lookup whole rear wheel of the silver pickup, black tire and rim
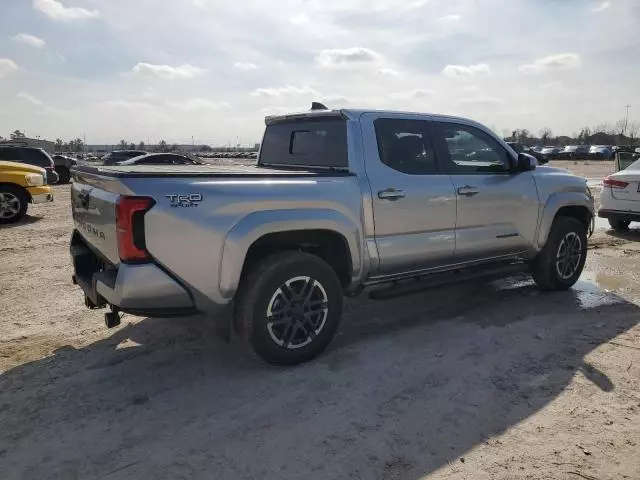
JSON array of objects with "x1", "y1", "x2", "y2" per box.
[{"x1": 236, "y1": 252, "x2": 343, "y2": 365}]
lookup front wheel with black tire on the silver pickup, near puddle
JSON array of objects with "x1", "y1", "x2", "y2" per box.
[{"x1": 531, "y1": 217, "x2": 587, "y2": 290}]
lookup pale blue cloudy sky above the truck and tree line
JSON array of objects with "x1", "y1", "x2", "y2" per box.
[{"x1": 0, "y1": 0, "x2": 640, "y2": 144}]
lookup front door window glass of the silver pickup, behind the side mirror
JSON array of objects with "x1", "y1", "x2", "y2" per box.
[{"x1": 434, "y1": 122, "x2": 509, "y2": 173}]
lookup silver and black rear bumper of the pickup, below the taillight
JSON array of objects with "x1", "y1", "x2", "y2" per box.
[{"x1": 70, "y1": 232, "x2": 198, "y2": 317}]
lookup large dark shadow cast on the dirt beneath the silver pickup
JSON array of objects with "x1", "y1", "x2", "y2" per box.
[{"x1": 0, "y1": 279, "x2": 640, "y2": 480}]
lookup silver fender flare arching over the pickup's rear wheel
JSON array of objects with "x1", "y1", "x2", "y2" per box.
[{"x1": 219, "y1": 208, "x2": 364, "y2": 299}]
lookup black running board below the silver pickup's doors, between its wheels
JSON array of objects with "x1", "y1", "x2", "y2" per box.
[{"x1": 369, "y1": 263, "x2": 530, "y2": 300}]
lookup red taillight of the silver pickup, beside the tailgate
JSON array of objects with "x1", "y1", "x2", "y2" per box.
[{"x1": 116, "y1": 196, "x2": 154, "y2": 262}]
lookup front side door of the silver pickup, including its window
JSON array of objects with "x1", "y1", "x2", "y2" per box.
[{"x1": 432, "y1": 121, "x2": 539, "y2": 262}]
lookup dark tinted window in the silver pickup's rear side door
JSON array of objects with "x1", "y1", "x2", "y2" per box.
[{"x1": 375, "y1": 118, "x2": 438, "y2": 175}]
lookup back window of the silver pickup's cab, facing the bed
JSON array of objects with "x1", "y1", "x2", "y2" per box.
[{"x1": 259, "y1": 118, "x2": 349, "y2": 168}]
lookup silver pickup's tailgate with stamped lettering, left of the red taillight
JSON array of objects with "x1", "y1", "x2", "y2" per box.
[{"x1": 71, "y1": 176, "x2": 120, "y2": 265}]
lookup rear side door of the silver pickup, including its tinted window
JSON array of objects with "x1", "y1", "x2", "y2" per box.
[{"x1": 361, "y1": 114, "x2": 456, "y2": 276}]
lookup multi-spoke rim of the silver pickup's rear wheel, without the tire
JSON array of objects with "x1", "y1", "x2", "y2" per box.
[{"x1": 266, "y1": 276, "x2": 329, "y2": 350}]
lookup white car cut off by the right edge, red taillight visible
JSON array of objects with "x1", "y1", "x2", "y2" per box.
[{"x1": 598, "y1": 156, "x2": 640, "y2": 232}]
